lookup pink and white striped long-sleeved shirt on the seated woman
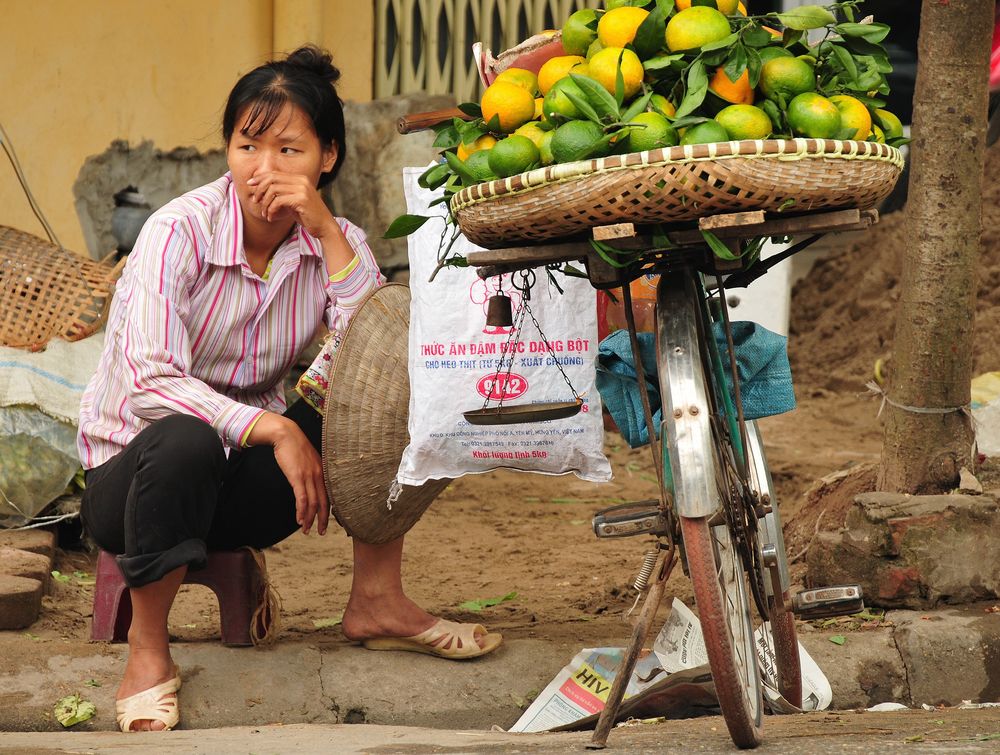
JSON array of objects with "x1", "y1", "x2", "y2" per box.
[{"x1": 77, "y1": 173, "x2": 385, "y2": 469}]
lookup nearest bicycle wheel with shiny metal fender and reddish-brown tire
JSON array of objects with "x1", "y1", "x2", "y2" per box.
[{"x1": 656, "y1": 272, "x2": 763, "y2": 748}]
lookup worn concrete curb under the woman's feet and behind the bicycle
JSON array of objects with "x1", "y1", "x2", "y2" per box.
[{"x1": 0, "y1": 604, "x2": 1000, "y2": 731}]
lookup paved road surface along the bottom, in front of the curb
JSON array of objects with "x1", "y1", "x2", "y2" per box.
[{"x1": 0, "y1": 708, "x2": 1000, "y2": 755}]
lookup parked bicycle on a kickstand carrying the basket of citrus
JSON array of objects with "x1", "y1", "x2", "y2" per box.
[{"x1": 399, "y1": 105, "x2": 878, "y2": 748}]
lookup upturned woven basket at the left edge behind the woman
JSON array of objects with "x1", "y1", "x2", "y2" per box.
[{"x1": 0, "y1": 226, "x2": 125, "y2": 351}]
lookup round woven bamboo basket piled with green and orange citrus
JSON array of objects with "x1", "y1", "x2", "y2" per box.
[{"x1": 451, "y1": 139, "x2": 903, "y2": 249}]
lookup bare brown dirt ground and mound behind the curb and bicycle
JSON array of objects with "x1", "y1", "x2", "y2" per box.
[{"x1": 31, "y1": 148, "x2": 1000, "y2": 660}]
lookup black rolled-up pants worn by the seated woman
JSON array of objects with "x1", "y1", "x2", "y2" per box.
[{"x1": 80, "y1": 401, "x2": 323, "y2": 587}]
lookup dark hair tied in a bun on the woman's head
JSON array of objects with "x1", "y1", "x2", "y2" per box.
[{"x1": 222, "y1": 45, "x2": 346, "y2": 188}]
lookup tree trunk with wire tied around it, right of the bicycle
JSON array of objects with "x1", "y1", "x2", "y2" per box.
[{"x1": 872, "y1": 0, "x2": 994, "y2": 493}]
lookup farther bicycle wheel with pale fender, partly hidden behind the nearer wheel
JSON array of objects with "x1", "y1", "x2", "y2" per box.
[{"x1": 747, "y1": 422, "x2": 802, "y2": 708}]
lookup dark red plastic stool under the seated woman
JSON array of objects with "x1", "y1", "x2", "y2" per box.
[{"x1": 90, "y1": 548, "x2": 264, "y2": 645}]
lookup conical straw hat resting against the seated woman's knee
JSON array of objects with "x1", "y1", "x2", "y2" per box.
[{"x1": 323, "y1": 283, "x2": 451, "y2": 544}]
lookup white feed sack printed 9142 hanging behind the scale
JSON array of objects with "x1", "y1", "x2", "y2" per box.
[{"x1": 398, "y1": 168, "x2": 611, "y2": 485}]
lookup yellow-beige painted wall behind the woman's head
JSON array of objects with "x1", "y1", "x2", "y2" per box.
[{"x1": 0, "y1": 0, "x2": 374, "y2": 254}]
